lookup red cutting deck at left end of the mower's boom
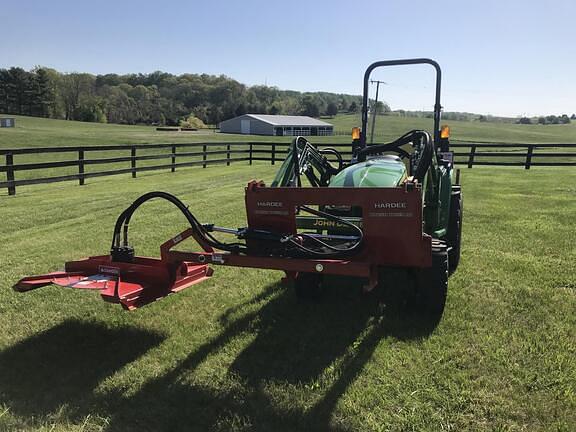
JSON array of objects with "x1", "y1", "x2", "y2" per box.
[{"x1": 14, "y1": 255, "x2": 212, "y2": 310}]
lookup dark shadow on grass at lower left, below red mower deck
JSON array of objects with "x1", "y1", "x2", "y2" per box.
[{"x1": 0, "y1": 320, "x2": 164, "y2": 419}]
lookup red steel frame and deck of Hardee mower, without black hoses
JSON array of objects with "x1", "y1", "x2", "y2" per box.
[{"x1": 14, "y1": 181, "x2": 432, "y2": 309}]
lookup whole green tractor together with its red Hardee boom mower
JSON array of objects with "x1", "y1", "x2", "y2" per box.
[{"x1": 14, "y1": 59, "x2": 462, "y2": 320}]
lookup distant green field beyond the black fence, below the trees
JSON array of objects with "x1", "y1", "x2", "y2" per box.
[{"x1": 0, "y1": 114, "x2": 576, "y2": 148}]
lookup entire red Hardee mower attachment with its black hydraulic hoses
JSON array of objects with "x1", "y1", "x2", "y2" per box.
[{"x1": 14, "y1": 182, "x2": 432, "y2": 310}]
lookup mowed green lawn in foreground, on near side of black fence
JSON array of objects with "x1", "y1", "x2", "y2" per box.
[{"x1": 0, "y1": 163, "x2": 576, "y2": 431}]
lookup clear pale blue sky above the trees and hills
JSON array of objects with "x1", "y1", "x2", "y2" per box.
[{"x1": 0, "y1": 0, "x2": 576, "y2": 116}]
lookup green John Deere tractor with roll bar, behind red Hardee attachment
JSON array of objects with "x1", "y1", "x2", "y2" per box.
[{"x1": 272, "y1": 59, "x2": 462, "y2": 318}]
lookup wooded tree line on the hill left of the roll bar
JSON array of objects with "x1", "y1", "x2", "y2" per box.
[{"x1": 0, "y1": 67, "x2": 362, "y2": 125}]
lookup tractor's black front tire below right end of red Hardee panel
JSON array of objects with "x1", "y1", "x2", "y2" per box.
[{"x1": 414, "y1": 243, "x2": 448, "y2": 327}]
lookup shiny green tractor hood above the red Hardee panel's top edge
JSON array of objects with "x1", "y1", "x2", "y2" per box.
[{"x1": 329, "y1": 155, "x2": 407, "y2": 187}]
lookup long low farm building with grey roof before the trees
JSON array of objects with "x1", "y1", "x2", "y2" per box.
[{"x1": 220, "y1": 114, "x2": 334, "y2": 136}]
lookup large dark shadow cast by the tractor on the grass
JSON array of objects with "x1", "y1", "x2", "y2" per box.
[{"x1": 103, "y1": 284, "x2": 436, "y2": 432}]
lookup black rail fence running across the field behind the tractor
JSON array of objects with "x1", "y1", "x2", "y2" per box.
[{"x1": 0, "y1": 142, "x2": 576, "y2": 195}]
